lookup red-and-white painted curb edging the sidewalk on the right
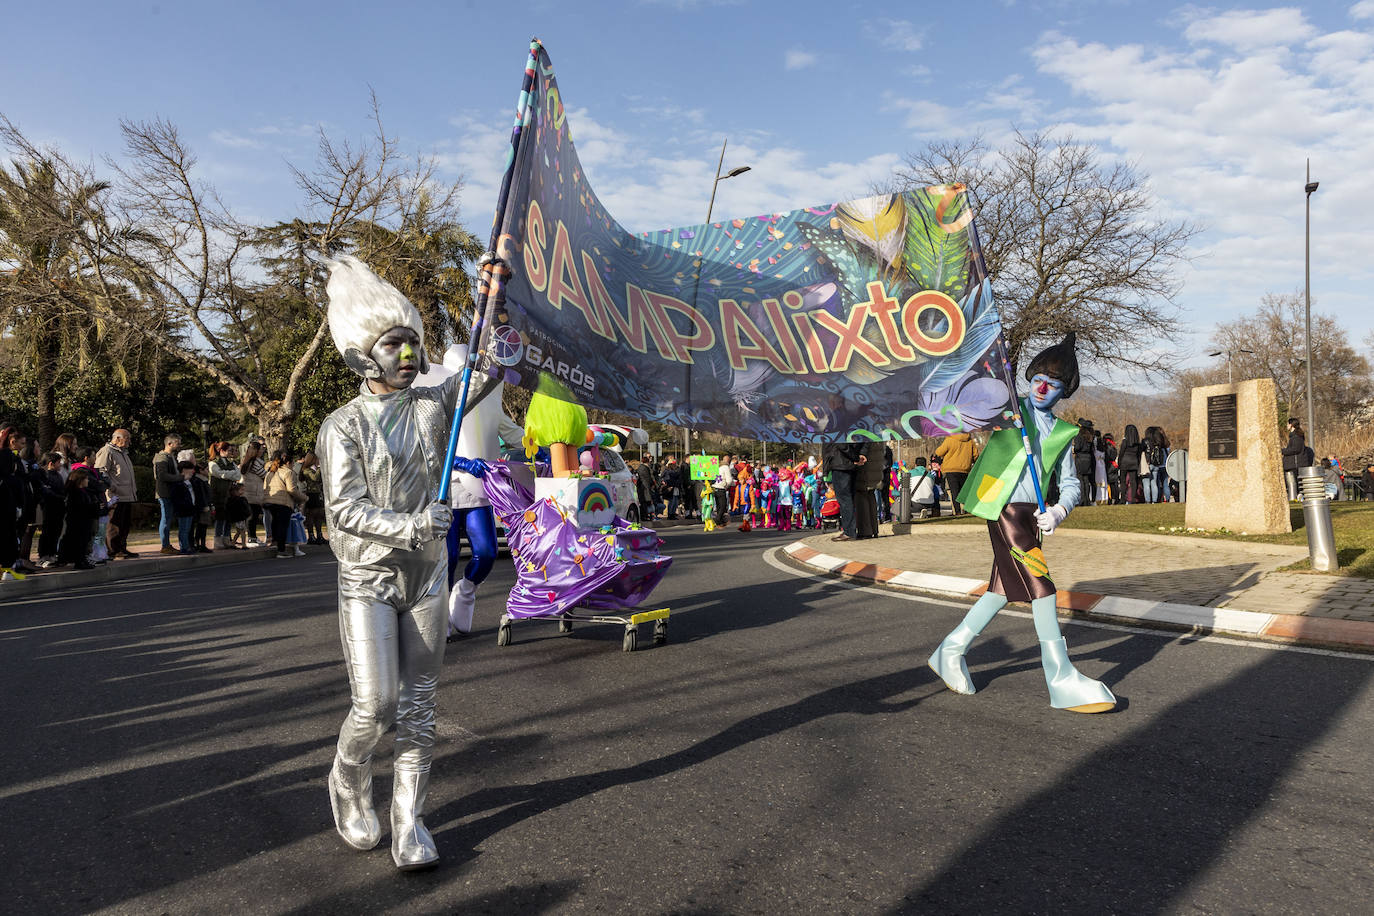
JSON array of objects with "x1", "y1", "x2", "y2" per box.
[{"x1": 782, "y1": 541, "x2": 1374, "y2": 652}]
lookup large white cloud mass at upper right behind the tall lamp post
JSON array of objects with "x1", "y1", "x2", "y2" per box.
[{"x1": 1032, "y1": 17, "x2": 1374, "y2": 354}]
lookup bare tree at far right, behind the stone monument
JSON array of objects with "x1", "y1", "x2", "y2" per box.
[{"x1": 1212, "y1": 290, "x2": 1374, "y2": 433}]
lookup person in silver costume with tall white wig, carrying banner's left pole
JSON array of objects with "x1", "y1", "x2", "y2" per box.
[{"x1": 315, "y1": 255, "x2": 472, "y2": 869}]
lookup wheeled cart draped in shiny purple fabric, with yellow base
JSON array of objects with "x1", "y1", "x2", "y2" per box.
[{"x1": 482, "y1": 461, "x2": 673, "y2": 652}]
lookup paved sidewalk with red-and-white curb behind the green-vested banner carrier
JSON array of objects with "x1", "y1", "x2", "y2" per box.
[{"x1": 785, "y1": 522, "x2": 1374, "y2": 651}]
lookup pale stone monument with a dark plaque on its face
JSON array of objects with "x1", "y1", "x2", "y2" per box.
[{"x1": 1183, "y1": 379, "x2": 1293, "y2": 534}]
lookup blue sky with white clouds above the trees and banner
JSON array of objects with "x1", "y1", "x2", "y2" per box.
[{"x1": 0, "y1": 0, "x2": 1374, "y2": 379}]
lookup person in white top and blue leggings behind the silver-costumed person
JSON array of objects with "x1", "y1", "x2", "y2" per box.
[{"x1": 415, "y1": 343, "x2": 525, "y2": 641}]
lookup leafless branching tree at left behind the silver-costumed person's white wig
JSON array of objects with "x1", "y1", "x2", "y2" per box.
[{"x1": 0, "y1": 99, "x2": 475, "y2": 448}]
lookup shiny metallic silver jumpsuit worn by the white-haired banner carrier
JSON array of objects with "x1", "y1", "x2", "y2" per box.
[{"x1": 316, "y1": 376, "x2": 460, "y2": 864}]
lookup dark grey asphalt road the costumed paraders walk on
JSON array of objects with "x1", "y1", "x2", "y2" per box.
[{"x1": 0, "y1": 531, "x2": 1374, "y2": 913}]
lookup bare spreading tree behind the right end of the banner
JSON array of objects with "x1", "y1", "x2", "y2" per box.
[{"x1": 897, "y1": 130, "x2": 1197, "y2": 372}]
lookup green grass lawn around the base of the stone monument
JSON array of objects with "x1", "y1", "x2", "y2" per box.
[{"x1": 923, "y1": 503, "x2": 1374, "y2": 578}]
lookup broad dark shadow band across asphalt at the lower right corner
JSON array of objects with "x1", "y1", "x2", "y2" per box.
[{"x1": 894, "y1": 640, "x2": 1374, "y2": 913}]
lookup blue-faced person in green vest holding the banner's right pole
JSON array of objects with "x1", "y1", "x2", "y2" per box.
[{"x1": 929, "y1": 332, "x2": 1116, "y2": 713}]
